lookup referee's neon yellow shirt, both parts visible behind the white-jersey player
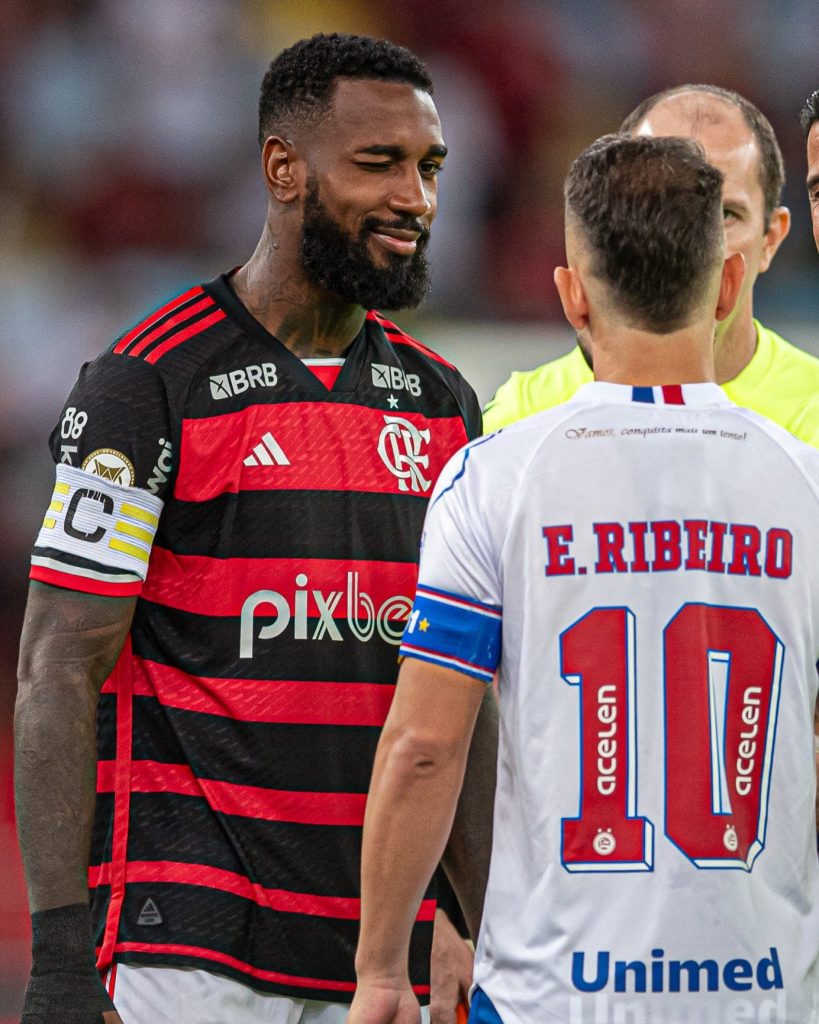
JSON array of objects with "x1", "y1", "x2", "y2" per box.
[{"x1": 483, "y1": 321, "x2": 819, "y2": 447}]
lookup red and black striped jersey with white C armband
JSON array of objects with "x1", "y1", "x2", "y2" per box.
[{"x1": 31, "y1": 278, "x2": 480, "y2": 1001}]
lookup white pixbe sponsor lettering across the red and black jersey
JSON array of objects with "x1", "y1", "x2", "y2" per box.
[{"x1": 239, "y1": 572, "x2": 413, "y2": 657}]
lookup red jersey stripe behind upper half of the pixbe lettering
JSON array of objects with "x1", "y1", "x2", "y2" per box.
[{"x1": 142, "y1": 546, "x2": 418, "y2": 625}]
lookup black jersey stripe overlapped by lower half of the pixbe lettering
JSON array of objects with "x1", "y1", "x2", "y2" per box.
[{"x1": 131, "y1": 598, "x2": 398, "y2": 683}]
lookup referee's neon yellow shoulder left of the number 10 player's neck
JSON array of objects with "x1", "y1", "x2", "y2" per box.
[{"x1": 483, "y1": 345, "x2": 592, "y2": 431}]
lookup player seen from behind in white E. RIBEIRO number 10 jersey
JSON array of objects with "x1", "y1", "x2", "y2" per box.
[{"x1": 349, "y1": 135, "x2": 819, "y2": 1024}]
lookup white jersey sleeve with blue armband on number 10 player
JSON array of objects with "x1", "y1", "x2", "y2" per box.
[{"x1": 400, "y1": 441, "x2": 502, "y2": 683}]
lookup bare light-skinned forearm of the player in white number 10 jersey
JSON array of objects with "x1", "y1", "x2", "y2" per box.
[{"x1": 356, "y1": 732, "x2": 465, "y2": 977}]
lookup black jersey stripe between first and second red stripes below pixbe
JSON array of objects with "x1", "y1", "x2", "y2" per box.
[{"x1": 127, "y1": 696, "x2": 381, "y2": 793}]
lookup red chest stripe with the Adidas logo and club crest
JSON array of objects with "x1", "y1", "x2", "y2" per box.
[{"x1": 174, "y1": 401, "x2": 467, "y2": 502}]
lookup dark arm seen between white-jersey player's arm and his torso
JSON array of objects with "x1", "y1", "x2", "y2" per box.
[{"x1": 443, "y1": 688, "x2": 499, "y2": 941}]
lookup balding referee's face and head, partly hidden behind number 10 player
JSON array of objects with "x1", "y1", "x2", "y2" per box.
[{"x1": 637, "y1": 91, "x2": 787, "y2": 330}]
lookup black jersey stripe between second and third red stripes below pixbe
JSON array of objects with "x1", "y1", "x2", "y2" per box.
[{"x1": 114, "y1": 793, "x2": 361, "y2": 897}]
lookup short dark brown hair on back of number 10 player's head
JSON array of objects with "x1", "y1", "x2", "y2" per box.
[{"x1": 564, "y1": 135, "x2": 725, "y2": 334}]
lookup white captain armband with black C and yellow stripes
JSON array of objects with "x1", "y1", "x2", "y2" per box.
[{"x1": 31, "y1": 465, "x2": 163, "y2": 596}]
